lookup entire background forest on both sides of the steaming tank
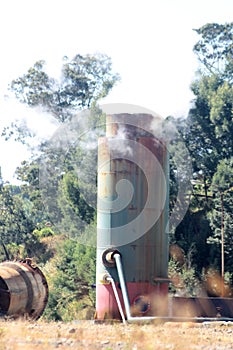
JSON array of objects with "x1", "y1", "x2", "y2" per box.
[{"x1": 0, "y1": 23, "x2": 233, "y2": 321}]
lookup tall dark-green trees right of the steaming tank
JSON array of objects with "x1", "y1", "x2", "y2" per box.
[{"x1": 175, "y1": 23, "x2": 233, "y2": 278}]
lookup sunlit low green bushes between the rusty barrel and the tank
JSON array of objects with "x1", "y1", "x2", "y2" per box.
[{"x1": 44, "y1": 239, "x2": 96, "y2": 321}]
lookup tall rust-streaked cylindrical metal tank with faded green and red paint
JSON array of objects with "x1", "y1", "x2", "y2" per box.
[{"x1": 96, "y1": 114, "x2": 169, "y2": 318}]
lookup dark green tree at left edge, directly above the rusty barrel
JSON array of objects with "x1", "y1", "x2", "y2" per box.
[{"x1": 0, "y1": 185, "x2": 52, "y2": 263}]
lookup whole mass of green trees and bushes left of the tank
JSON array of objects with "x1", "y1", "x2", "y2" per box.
[{"x1": 0, "y1": 54, "x2": 119, "y2": 321}]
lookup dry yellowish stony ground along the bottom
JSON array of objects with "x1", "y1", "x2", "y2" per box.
[{"x1": 0, "y1": 320, "x2": 233, "y2": 350}]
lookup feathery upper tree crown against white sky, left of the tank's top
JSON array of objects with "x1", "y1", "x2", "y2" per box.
[{"x1": 10, "y1": 54, "x2": 119, "y2": 123}]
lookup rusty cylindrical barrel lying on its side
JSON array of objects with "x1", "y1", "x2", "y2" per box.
[{"x1": 0, "y1": 259, "x2": 48, "y2": 319}]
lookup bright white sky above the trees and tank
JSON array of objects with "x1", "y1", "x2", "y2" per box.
[{"x1": 0, "y1": 0, "x2": 233, "y2": 179}]
